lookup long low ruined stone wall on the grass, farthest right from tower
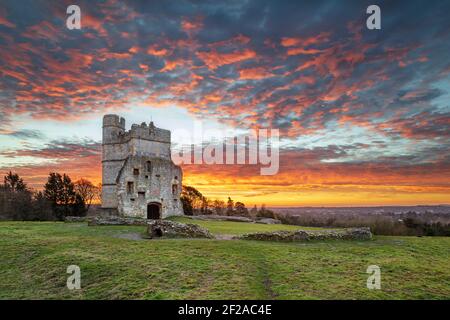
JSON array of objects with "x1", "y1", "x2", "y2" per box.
[{"x1": 235, "y1": 228, "x2": 372, "y2": 242}]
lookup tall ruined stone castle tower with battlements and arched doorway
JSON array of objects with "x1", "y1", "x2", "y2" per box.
[{"x1": 102, "y1": 114, "x2": 183, "y2": 219}]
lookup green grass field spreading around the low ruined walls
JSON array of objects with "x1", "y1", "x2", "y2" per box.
[{"x1": 0, "y1": 218, "x2": 450, "y2": 299}]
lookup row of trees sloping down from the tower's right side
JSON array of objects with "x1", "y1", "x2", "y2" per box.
[{"x1": 181, "y1": 186, "x2": 275, "y2": 218}]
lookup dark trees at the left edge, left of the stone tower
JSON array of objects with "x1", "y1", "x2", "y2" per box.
[{"x1": 0, "y1": 171, "x2": 101, "y2": 220}]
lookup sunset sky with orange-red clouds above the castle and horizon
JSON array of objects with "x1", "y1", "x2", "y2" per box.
[{"x1": 0, "y1": 0, "x2": 450, "y2": 206}]
